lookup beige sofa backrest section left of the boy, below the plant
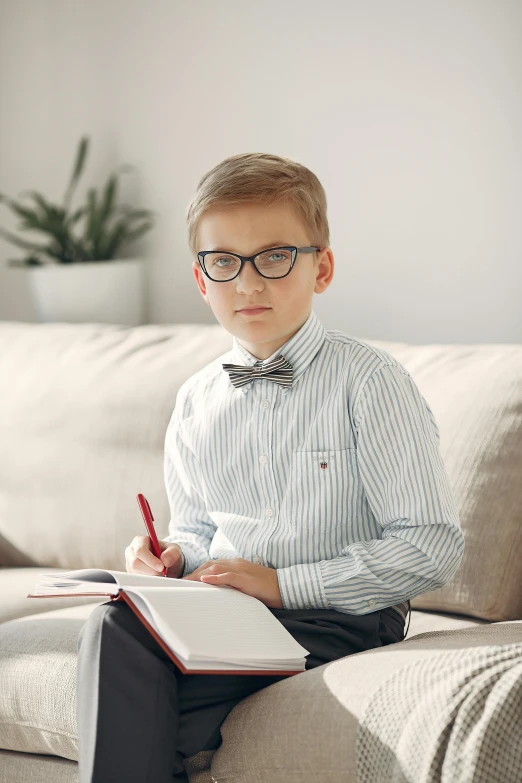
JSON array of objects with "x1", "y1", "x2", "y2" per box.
[{"x1": 0, "y1": 321, "x2": 232, "y2": 571}]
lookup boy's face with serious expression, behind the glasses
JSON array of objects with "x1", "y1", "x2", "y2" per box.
[{"x1": 192, "y1": 203, "x2": 334, "y2": 359}]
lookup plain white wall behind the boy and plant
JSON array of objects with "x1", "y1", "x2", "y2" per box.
[{"x1": 0, "y1": 0, "x2": 522, "y2": 343}]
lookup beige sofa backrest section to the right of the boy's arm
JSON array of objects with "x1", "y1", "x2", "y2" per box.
[{"x1": 366, "y1": 340, "x2": 522, "y2": 622}]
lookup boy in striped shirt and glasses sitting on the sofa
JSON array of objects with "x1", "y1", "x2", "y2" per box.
[{"x1": 78, "y1": 154, "x2": 464, "y2": 783}]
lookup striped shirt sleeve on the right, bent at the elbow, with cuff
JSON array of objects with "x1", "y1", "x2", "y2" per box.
[{"x1": 277, "y1": 364, "x2": 464, "y2": 614}]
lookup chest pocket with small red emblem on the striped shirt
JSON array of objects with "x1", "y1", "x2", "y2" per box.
[{"x1": 288, "y1": 448, "x2": 359, "y2": 532}]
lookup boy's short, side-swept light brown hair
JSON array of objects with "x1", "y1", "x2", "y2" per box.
[{"x1": 186, "y1": 152, "x2": 330, "y2": 258}]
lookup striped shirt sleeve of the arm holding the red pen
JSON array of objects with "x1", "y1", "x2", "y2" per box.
[{"x1": 163, "y1": 392, "x2": 213, "y2": 576}]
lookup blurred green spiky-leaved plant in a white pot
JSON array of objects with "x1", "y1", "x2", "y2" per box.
[{"x1": 0, "y1": 136, "x2": 155, "y2": 325}]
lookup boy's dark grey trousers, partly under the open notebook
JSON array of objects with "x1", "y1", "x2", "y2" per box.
[{"x1": 77, "y1": 601, "x2": 404, "y2": 783}]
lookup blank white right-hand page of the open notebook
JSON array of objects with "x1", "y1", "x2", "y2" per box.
[{"x1": 126, "y1": 585, "x2": 309, "y2": 662}]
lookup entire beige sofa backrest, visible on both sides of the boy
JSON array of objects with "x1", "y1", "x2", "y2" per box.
[{"x1": 0, "y1": 321, "x2": 522, "y2": 621}]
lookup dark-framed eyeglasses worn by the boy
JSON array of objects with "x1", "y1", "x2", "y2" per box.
[{"x1": 198, "y1": 245, "x2": 321, "y2": 283}]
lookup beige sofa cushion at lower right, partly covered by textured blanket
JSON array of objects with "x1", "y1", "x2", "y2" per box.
[{"x1": 211, "y1": 621, "x2": 522, "y2": 783}]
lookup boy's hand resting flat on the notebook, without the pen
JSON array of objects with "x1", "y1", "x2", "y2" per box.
[{"x1": 181, "y1": 557, "x2": 283, "y2": 609}]
